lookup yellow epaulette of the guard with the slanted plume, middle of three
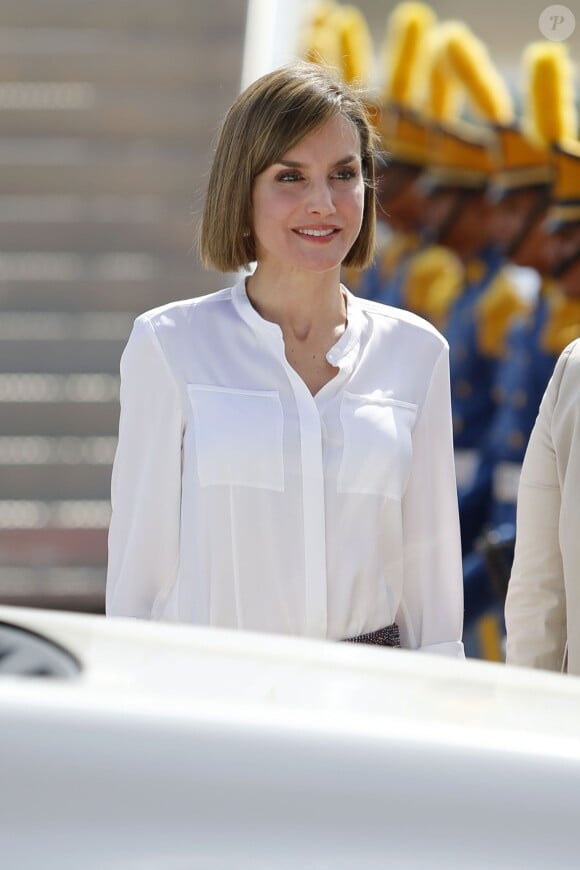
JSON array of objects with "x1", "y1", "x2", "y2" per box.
[{"x1": 476, "y1": 270, "x2": 530, "y2": 358}]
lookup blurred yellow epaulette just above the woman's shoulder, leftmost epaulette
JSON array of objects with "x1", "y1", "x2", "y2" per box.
[{"x1": 403, "y1": 245, "x2": 464, "y2": 328}]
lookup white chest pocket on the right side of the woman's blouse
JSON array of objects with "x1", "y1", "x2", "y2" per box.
[{"x1": 337, "y1": 393, "x2": 417, "y2": 499}]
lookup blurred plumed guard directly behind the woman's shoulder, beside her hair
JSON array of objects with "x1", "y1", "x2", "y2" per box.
[{"x1": 365, "y1": 3, "x2": 463, "y2": 327}]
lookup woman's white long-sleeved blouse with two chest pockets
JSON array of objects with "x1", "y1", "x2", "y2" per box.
[{"x1": 107, "y1": 281, "x2": 463, "y2": 656}]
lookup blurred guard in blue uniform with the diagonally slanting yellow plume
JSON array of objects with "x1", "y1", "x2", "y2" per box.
[{"x1": 416, "y1": 22, "x2": 526, "y2": 554}]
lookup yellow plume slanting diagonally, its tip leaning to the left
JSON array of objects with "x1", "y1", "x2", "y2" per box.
[{"x1": 444, "y1": 21, "x2": 514, "y2": 124}]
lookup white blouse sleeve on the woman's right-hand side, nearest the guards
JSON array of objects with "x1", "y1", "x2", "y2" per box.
[{"x1": 397, "y1": 345, "x2": 464, "y2": 657}]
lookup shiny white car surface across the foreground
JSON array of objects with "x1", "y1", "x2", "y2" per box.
[{"x1": 0, "y1": 608, "x2": 580, "y2": 870}]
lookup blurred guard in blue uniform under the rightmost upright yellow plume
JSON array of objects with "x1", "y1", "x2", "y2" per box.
[{"x1": 464, "y1": 43, "x2": 580, "y2": 658}]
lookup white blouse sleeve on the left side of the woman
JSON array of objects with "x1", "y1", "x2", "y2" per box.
[{"x1": 106, "y1": 319, "x2": 183, "y2": 618}]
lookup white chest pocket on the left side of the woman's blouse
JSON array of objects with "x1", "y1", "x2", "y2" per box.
[{"x1": 187, "y1": 384, "x2": 284, "y2": 492}]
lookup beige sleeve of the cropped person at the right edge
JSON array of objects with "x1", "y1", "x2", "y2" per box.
[{"x1": 505, "y1": 351, "x2": 569, "y2": 671}]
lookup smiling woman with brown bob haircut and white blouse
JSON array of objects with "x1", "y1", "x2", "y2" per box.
[{"x1": 107, "y1": 64, "x2": 462, "y2": 655}]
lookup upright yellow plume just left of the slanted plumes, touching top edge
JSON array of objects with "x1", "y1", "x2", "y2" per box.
[{"x1": 382, "y1": 0, "x2": 436, "y2": 106}]
